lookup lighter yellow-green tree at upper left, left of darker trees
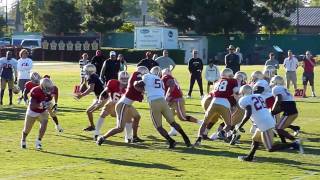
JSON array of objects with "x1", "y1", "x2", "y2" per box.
[{"x1": 20, "y1": 0, "x2": 42, "y2": 32}]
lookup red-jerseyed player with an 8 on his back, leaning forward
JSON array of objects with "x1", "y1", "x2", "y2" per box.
[{"x1": 195, "y1": 68, "x2": 239, "y2": 146}]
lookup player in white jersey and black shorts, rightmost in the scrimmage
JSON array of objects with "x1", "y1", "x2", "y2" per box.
[{"x1": 270, "y1": 76, "x2": 300, "y2": 142}]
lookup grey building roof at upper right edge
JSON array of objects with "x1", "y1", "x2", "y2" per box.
[{"x1": 288, "y1": 7, "x2": 320, "y2": 26}]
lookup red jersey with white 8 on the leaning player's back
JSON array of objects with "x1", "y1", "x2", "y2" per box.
[{"x1": 213, "y1": 78, "x2": 238, "y2": 99}]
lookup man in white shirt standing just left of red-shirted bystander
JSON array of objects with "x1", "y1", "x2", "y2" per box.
[{"x1": 283, "y1": 50, "x2": 299, "y2": 90}]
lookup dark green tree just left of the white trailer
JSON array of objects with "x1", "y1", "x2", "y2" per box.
[{"x1": 82, "y1": 0, "x2": 123, "y2": 33}]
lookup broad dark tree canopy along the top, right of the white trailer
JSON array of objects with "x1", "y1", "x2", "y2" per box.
[{"x1": 161, "y1": 0, "x2": 296, "y2": 34}]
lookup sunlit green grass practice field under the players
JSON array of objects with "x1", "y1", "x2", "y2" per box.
[{"x1": 0, "y1": 63, "x2": 320, "y2": 180}]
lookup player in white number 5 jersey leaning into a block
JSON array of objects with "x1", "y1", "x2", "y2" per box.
[{"x1": 135, "y1": 66, "x2": 191, "y2": 148}]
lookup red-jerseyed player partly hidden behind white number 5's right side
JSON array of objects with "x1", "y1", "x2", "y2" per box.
[{"x1": 161, "y1": 69, "x2": 202, "y2": 136}]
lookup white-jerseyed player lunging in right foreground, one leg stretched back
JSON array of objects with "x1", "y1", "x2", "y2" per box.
[{"x1": 232, "y1": 85, "x2": 303, "y2": 161}]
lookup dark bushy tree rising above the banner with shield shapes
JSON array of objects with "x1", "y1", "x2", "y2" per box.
[{"x1": 40, "y1": 0, "x2": 82, "y2": 34}]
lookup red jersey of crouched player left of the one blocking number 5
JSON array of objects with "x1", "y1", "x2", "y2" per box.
[{"x1": 107, "y1": 79, "x2": 126, "y2": 102}]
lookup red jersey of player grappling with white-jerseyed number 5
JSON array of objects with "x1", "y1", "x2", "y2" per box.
[{"x1": 125, "y1": 72, "x2": 143, "y2": 102}]
